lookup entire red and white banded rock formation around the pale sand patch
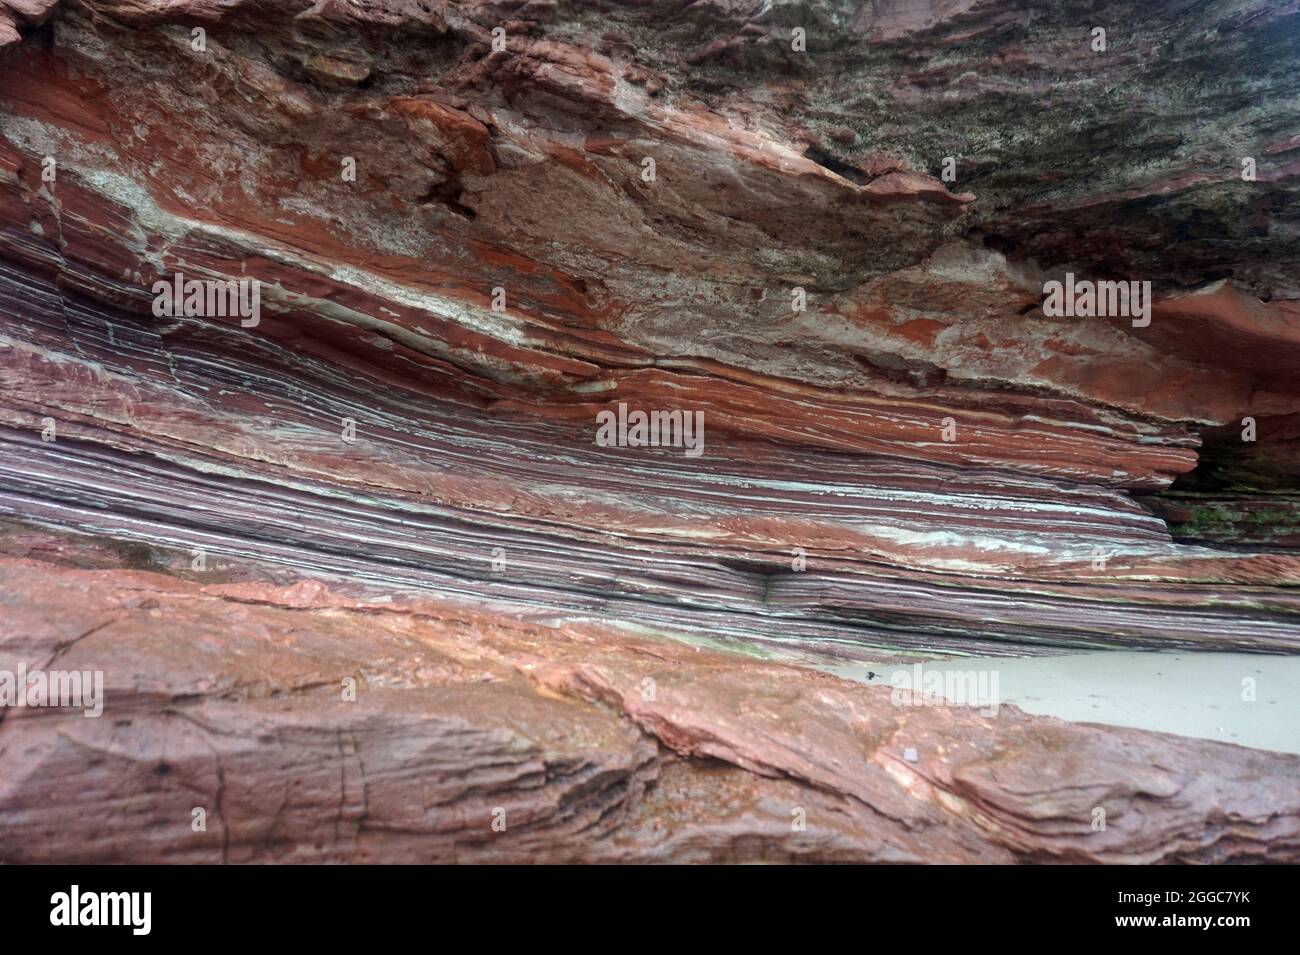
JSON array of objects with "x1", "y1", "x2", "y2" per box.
[{"x1": 0, "y1": 0, "x2": 1300, "y2": 861}]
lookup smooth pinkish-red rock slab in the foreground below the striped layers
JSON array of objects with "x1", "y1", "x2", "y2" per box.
[{"x1": 0, "y1": 535, "x2": 1300, "y2": 863}]
